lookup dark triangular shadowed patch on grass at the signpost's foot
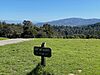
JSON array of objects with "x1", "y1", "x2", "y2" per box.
[{"x1": 27, "y1": 63, "x2": 54, "y2": 75}]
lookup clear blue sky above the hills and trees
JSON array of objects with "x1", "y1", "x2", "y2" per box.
[{"x1": 0, "y1": 0, "x2": 100, "y2": 22}]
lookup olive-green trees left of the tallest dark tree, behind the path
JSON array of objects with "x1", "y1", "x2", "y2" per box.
[{"x1": 0, "y1": 22, "x2": 23, "y2": 38}]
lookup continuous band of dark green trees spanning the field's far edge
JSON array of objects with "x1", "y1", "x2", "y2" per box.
[{"x1": 0, "y1": 20, "x2": 100, "y2": 39}]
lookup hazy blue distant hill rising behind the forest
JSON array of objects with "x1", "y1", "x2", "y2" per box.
[{"x1": 37, "y1": 18, "x2": 100, "y2": 26}]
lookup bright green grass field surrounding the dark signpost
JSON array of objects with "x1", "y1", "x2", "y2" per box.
[{"x1": 0, "y1": 39, "x2": 100, "y2": 75}]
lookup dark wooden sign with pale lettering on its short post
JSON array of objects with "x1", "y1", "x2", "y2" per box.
[{"x1": 34, "y1": 42, "x2": 51, "y2": 66}]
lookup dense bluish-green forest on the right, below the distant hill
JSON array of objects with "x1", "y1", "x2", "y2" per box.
[{"x1": 53, "y1": 23, "x2": 100, "y2": 39}]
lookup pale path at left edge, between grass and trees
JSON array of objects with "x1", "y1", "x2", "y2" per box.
[{"x1": 0, "y1": 38, "x2": 32, "y2": 46}]
